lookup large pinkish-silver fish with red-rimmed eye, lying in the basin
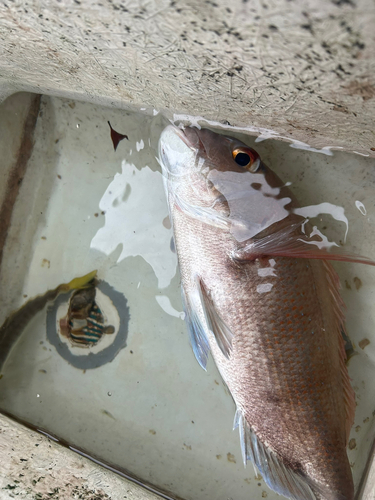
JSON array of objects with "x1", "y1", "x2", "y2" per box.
[{"x1": 159, "y1": 125, "x2": 375, "y2": 500}]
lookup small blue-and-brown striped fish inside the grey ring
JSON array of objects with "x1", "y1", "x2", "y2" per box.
[{"x1": 59, "y1": 279, "x2": 115, "y2": 347}]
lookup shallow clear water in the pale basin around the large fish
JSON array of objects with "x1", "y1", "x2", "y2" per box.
[{"x1": 0, "y1": 97, "x2": 375, "y2": 500}]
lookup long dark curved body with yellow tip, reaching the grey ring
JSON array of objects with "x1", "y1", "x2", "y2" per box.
[{"x1": 0, "y1": 270, "x2": 97, "y2": 368}]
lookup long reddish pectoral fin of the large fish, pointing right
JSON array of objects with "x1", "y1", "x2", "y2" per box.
[{"x1": 231, "y1": 222, "x2": 375, "y2": 266}]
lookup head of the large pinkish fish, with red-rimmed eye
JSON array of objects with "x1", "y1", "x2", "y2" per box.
[{"x1": 159, "y1": 125, "x2": 296, "y2": 241}]
